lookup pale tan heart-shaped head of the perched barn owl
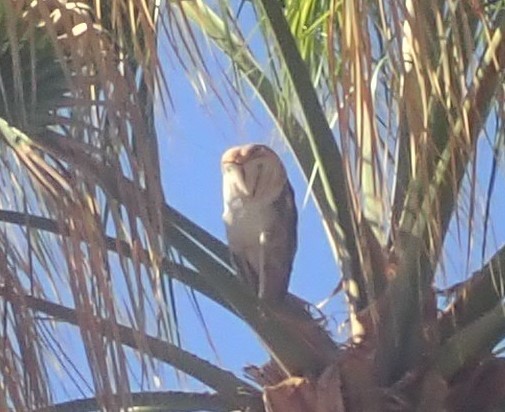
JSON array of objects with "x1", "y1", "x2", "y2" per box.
[{"x1": 221, "y1": 144, "x2": 287, "y2": 203}]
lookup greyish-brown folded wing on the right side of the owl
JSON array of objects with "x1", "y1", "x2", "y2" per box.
[{"x1": 258, "y1": 182, "x2": 298, "y2": 302}]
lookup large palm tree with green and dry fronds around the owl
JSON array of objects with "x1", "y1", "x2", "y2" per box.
[{"x1": 0, "y1": 0, "x2": 505, "y2": 412}]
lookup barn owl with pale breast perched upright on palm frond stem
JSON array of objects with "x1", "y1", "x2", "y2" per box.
[{"x1": 221, "y1": 144, "x2": 297, "y2": 303}]
